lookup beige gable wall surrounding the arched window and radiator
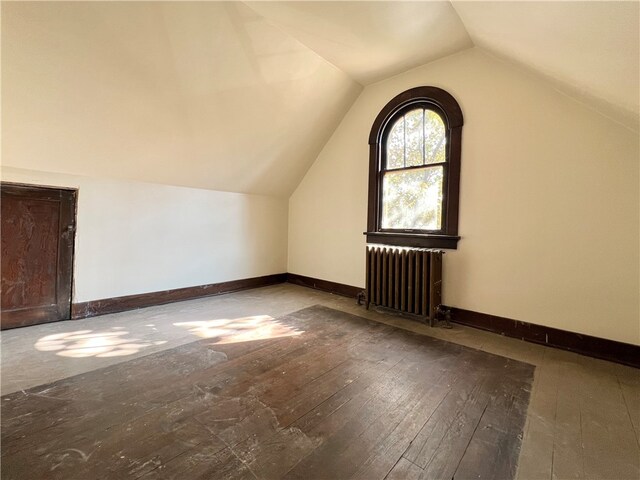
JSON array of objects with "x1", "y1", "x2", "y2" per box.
[{"x1": 288, "y1": 49, "x2": 640, "y2": 344}]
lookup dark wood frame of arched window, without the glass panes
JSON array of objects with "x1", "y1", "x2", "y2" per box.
[{"x1": 365, "y1": 87, "x2": 464, "y2": 249}]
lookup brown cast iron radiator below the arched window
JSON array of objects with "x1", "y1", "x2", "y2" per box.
[{"x1": 365, "y1": 245, "x2": 442, "y2": 325}]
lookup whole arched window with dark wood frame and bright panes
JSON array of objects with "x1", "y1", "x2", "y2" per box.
[{"x1": 365, "y1": 87, "x2": 463, "y2": 248}]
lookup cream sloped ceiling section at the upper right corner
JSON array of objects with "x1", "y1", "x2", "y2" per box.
[{"x1": 453, "y1": 1, "x2": 640, "y2": 130}]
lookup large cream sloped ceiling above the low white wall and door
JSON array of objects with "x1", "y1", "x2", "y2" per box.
[{"x1": 2, "y1": 2, "x2": 362, "y2": 197}]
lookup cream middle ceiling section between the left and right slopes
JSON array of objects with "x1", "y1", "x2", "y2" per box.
[{"x1": 242, "y1": 1, "x2": 473, "y2": 85}]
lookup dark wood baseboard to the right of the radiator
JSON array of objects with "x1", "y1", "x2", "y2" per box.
[{"x1": 451, "y1": 308, "x2": 640, "y2": 368}]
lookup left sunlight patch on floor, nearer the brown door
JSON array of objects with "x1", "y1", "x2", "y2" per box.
[{"x1": 34, "y1": 327, "x2": 167, "y2": 358}]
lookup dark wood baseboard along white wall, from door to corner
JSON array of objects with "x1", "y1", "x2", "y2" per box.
[{"x1": 71, "y1": 273, "x2": 287, "y2": 320}]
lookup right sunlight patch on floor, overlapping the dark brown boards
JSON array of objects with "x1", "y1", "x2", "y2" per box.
[{"x1": 174, "y1": 315, "x2": 304, "y2": 345}]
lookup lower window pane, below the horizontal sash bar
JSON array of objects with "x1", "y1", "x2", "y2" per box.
[{"x1": 382, "y1": 166, "x2": 444, "y2": 230}]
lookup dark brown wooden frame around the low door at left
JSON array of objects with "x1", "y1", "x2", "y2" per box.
[{"x1": 0, "y1": 181, "x2": 78, "y2": 330}]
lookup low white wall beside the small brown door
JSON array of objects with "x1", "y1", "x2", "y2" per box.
[{"x1": 2, "y1": 167, "x2": 287, "y2": 302}]
